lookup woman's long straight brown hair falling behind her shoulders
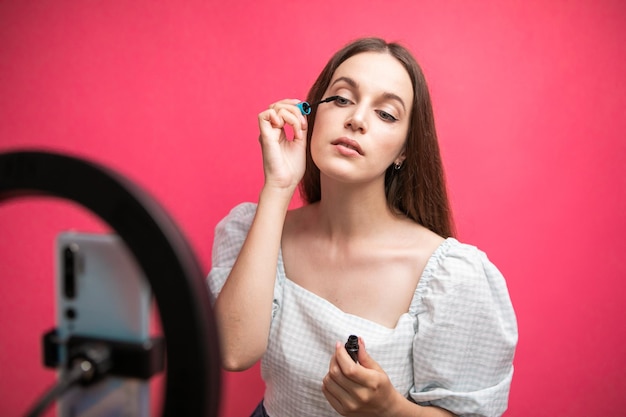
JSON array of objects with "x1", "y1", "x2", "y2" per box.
[{"x1": 300, "y1": 38, "x2": 455, "y2": 237}]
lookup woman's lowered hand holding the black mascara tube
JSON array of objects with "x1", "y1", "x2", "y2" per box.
[{"x1": 322, "y1": 338, "x2": 405, "y2": 416}]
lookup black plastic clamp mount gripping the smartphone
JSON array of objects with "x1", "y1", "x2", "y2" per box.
[{"x1": 42, "y1": 329, "x2": 165, "y2": 380}]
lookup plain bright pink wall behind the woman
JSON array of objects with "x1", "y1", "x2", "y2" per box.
[{"x1": 0, "y1": 0, "x2": 626, "y2": 417}]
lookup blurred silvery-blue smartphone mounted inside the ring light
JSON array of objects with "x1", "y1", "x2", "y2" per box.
[{"x1": 55, "y1": 232, "x2": 152, "y2": 417}]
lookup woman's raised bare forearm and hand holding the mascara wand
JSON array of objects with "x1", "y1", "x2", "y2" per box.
[{"x1": 215, "y1": 100, "x2": 307, "y2": 371}]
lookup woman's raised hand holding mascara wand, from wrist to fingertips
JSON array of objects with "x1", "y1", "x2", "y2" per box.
[{"x1": 259, "y1": 99, "x2": 307, "y2": 191}]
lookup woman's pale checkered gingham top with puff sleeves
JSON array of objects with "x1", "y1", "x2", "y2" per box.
[{"x1": 208, "y1": 203, "x2": 517, "y2": 417}]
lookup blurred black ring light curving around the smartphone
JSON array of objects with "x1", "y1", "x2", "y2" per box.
[{"x1": 0, "y1": 151, "x2": 221, "y2": 417}]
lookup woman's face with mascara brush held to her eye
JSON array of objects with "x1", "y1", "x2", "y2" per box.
[{"x1": 311, "y1": 52, "x2": 413, "y2": 186}]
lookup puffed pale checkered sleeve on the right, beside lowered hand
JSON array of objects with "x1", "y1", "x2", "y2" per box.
[{"x1": 409, "y1": 241, "x2": 517, "y2": 417}]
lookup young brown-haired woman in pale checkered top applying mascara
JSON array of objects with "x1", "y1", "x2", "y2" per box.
[{"x1": 208, "y1": 38, "x2": 517, "y2": 417}]
